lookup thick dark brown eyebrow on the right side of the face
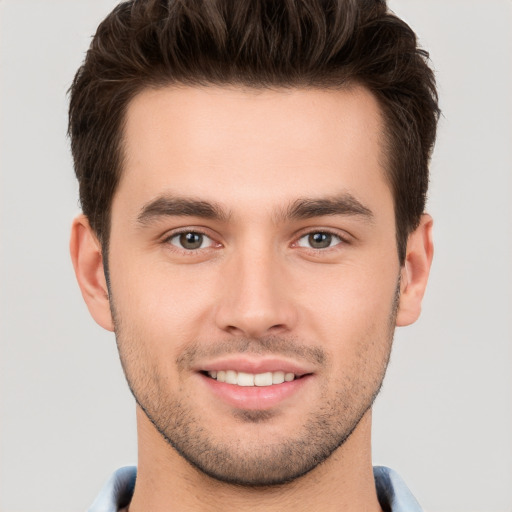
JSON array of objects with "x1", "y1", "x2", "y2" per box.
[{"x1": 282, "y1": 193, "x2": 374, "y2": 222}]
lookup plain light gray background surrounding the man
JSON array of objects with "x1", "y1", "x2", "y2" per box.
[{"x1": 0, "y1": 0, "x2": 512, "y2": 512}]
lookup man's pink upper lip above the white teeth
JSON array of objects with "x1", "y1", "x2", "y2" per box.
[{"x1": 194, "y1": 354, "x2": 313, "y2": 377}]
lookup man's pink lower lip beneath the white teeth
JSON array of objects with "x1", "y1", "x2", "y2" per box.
[{"x1": 199, "y1": 374, "x2": 312, "y2": 411}]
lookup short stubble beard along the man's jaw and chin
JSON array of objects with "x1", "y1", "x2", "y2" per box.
[{"x1": 111, "y1": 284, "x2": 399, "y2": 487}]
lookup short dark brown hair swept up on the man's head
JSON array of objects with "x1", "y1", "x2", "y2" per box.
[{"x1": 69, "y1": 0, "x2": 439, "y2": 263}]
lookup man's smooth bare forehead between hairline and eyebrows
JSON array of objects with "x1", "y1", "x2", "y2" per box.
[{"x1": 118, "y1": 86, "x2": 389, "y2": 214}]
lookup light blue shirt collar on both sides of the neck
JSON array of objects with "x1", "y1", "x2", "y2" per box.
[{"x1": 88, "y1": 466, "x2": 422, "y2": 512}]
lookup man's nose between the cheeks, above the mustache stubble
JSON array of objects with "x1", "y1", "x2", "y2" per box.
[{"x1": 216, "y1": 245, "x2": 298, "y2": 338}]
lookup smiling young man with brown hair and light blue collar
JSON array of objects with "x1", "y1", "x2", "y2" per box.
[{"x1": 69, "y1": 0, "x2": 438, "y2": 512}]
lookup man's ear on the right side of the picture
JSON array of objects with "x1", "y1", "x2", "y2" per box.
[{"x1": 396, "y1": 214, "x2": 434, "y2": 327}]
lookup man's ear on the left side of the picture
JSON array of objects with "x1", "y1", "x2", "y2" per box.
[{"x1": 69, "y1": 215, "x2": 114, "y2": 331}]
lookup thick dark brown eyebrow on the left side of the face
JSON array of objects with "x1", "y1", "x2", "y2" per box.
[{"x1": 137, "y1": 196, "x2": 230, "y2": 225}]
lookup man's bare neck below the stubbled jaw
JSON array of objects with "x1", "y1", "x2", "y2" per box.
[{"x1": 129, "y1": 409, "x2": 381, "y2": 512}]
